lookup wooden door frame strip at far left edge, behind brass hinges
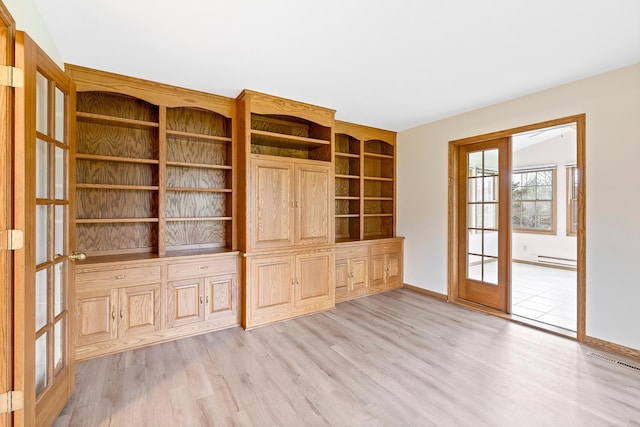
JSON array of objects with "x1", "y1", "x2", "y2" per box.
[{"x1": 0, "y1": 1, "x2": 16, "y2": 427}]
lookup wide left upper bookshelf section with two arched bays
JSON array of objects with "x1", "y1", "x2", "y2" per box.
[{"x1": 67, "y1": 66, "x2": 235, "y2": 262}]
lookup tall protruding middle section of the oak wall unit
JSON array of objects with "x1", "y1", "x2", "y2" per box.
[{"x1": 237, "y1": 90, "x2": 335, "y2": 328}]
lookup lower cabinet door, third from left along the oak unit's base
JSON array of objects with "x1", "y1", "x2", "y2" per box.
[{"x1": 167, "y1": 279, "x2": 204, "y2": 328}]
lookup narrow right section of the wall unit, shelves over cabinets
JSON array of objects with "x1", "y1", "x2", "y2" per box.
[{"x1": 335, "y1": 121, "x2": 403, "y2": 302}]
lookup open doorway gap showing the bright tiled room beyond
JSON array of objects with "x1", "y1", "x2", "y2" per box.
[{"x1": 511, "y1": 123, "x2": 579, "y2": 335}]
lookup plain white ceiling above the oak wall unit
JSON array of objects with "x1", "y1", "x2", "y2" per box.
[{"x1": 35, "y1": 0, "x2": 640, "y2": 130}]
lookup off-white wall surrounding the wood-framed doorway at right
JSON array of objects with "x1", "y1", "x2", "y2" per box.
[{"x1": 397, "y1": 64, "x2": 640, "y2": 349}]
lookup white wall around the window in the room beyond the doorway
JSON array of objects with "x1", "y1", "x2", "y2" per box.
[{"x1": 511, "y1": 130, "x2": 577, "y2": 262}]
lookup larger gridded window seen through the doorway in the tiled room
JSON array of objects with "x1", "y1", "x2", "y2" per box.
[{"x1": 511, "y1": 167, "x2": 556, "y2": 234}]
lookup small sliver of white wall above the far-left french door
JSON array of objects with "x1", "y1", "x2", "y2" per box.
[{"x1": 2, "y1": 0, "x2": 64, "y2": 68}]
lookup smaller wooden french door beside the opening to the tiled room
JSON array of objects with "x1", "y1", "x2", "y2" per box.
[{"x1": 457, "y1": 137, "x2": 511, "y2": 312}]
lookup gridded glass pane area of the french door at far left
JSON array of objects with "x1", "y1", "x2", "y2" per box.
[{"x1": 34, "y1": 71, "x2": 70, "y2": 398}]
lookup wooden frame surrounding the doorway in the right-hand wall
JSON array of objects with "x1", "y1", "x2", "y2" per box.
[{"x1": 447, "y1": 114, "x2": 587, "y2": 342}]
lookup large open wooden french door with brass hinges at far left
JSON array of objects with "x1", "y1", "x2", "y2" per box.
[{"x1": 13, "y1": 32, "x2": 77, "y2": 426}]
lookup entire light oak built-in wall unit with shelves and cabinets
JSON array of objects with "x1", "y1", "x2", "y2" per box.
[{"x1": 62, "y1": 65, "x2": 403, "y2": 354}]
